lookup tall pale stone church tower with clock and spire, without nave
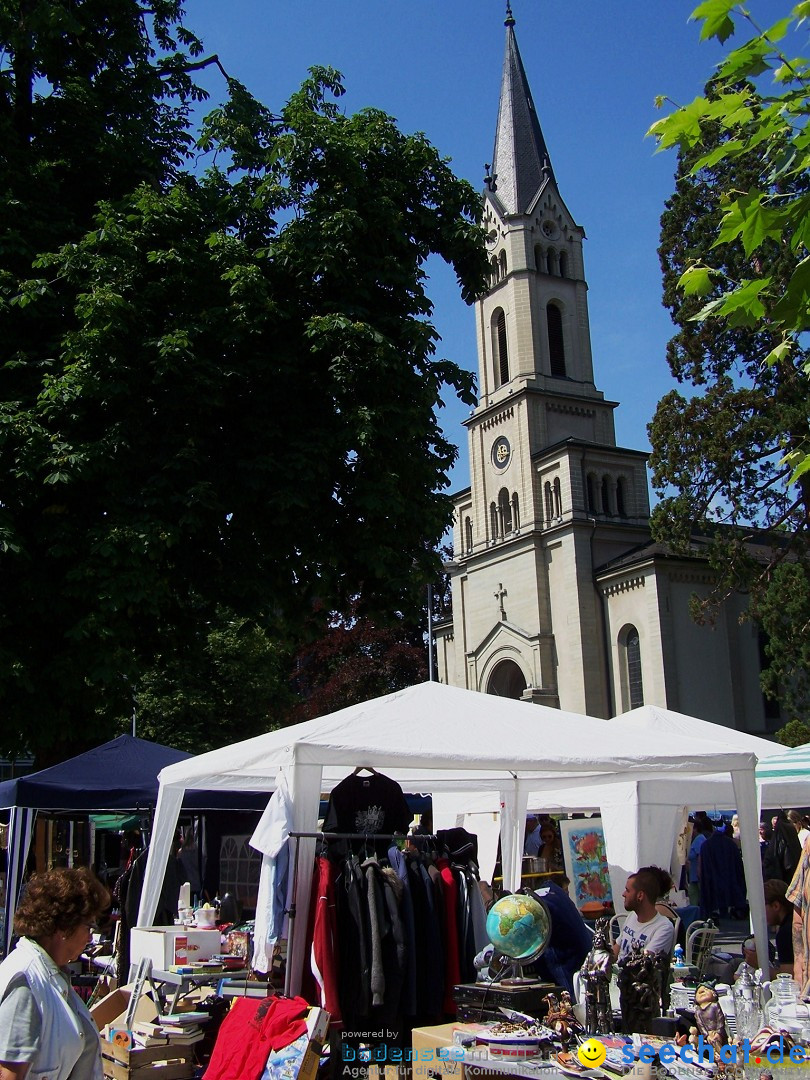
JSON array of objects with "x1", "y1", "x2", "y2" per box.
[{"x1": 436, "y1": 6, "x2": 649, "y2": 716}]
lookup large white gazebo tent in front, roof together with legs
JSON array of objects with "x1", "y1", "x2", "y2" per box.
[{"x1": 138, "y1": 683, "x2": 767, "y2": 993}]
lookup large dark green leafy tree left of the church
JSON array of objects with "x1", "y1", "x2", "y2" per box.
[{"x1": 0, "y1": 0, "x2": 486, "y2": 753}]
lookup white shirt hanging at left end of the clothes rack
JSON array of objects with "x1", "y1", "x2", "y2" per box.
[{"x1": 249, "y1": 772, "x2": 293, "y2": 973}]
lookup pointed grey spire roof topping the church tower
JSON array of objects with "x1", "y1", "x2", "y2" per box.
[{"x1": 488, "y1": 3, "x2": 554, "y2": 214}]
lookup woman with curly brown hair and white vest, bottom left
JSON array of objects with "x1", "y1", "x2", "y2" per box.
[{"x1": 0, "y1": 868, "x2": 110, "y2": 1080}]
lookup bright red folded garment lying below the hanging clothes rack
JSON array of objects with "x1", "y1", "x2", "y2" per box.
[{"x1": 205, "y1": 997, "x2": 309, "y2": 1080}]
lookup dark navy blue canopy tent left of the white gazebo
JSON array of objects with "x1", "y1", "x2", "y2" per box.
[{"x1": 0, "y1": 735, "x2": 268, "y2": 953}]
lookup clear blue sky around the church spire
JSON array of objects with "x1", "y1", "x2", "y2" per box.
[{"x1": 187, "y1": 0, "x2": 788, "y2": 488}]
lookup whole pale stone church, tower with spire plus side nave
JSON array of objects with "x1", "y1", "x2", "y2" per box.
[{"x1": 435, "y1": 13, "x2": 782, "y2": 733}]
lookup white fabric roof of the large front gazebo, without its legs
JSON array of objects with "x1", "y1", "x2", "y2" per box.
[{"x1": 160, "y1": 683, "x2": 754, "y2": 792}]
